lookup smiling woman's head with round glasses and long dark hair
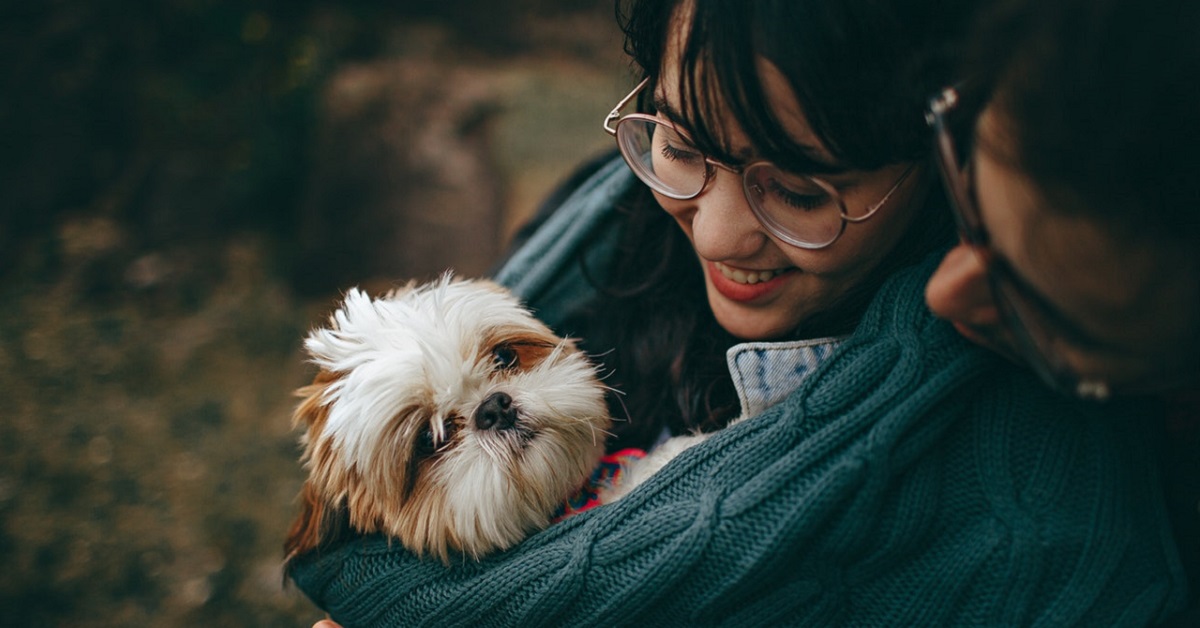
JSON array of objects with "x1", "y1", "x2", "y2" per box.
[{"x1": 571, "y1": 2, "x2": 971, "y2": 447}]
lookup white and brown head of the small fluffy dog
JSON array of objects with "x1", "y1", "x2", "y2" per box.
[{"x1": 287, "y1": 277, "x2": 610, "y2": 561}]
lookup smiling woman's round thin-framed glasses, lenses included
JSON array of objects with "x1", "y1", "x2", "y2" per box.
[{"x1": 604, "y1": 78, "x2": 916, "y2": 249}]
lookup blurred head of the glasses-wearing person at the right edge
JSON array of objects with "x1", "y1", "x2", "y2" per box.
[{"x1": 926, "y1": 0, "x2": 1200, "y2": 396}]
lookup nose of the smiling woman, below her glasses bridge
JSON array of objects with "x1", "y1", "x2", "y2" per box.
[{"x1": 691, "y1": 169, "x2": 767, "y2": 262}]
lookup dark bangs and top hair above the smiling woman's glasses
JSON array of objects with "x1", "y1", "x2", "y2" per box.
[{"x1": 619, "y1": 0, "x2": 974, "y2": 173}]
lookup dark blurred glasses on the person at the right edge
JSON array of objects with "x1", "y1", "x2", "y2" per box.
[{"x1": 925, "y1": 88, "x2": 1111, "y2": 399}]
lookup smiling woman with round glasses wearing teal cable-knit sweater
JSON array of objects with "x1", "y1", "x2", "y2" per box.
[{"x1": 292, "y1": 0, "x2": 1183, "y2": 626}]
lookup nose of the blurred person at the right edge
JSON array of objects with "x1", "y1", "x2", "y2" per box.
[{"x1": 925, "y1": 244, "x2": 1000, "y2": 330}]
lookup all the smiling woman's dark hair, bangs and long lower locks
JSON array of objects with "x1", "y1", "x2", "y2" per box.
[{"x1": 572, "y1": 0, "x2": 970, "y2": 447}]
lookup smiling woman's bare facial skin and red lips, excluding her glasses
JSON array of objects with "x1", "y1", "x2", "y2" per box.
[{"x1": 654, "y1": 56, "x2": 928, "y2": 340}]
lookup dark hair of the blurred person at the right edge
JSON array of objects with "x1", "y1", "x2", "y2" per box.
[{"x1": 966, "y1": 0, "x2": 1200, "y2": 248}]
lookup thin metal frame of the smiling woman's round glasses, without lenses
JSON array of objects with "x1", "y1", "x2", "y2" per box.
[{"x1": 602, "y1": 77, "x2": 917, "y2": 251}]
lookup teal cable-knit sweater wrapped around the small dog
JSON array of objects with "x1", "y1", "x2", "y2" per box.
[{"x1": 285, "y1": 158, "x2": 1186, "y2": 628}]
